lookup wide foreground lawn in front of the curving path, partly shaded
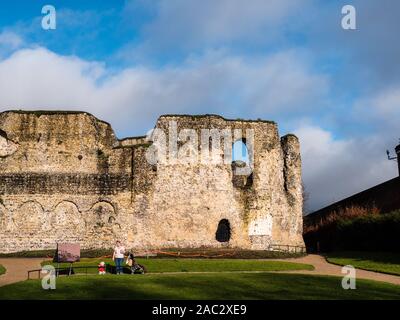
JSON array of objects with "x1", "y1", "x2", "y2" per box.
[{"x1": 0, "y1": 272, "x2": 400, "y2": 300}]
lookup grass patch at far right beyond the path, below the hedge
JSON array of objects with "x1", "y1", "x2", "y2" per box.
[{"x1": 327, "y1": 251, "x2": 400, "y2": 275}]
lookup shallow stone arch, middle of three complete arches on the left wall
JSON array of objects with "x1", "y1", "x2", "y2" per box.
[{"x1": 51, "y1": 200, "x2": 85, "y2": 234}]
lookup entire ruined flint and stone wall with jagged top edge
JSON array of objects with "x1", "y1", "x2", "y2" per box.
[{"x1": 0, "y1": 111, "x2": 304, "y2": 252}]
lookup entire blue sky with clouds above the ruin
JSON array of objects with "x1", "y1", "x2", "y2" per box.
[{"x1": 0, "y1": 0, "x2": 400, "y2": 211}]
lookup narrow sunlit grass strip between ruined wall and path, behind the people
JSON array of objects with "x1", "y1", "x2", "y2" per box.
[{"x1": 42, "y1": 258, "x2": 314, "y2": 273}]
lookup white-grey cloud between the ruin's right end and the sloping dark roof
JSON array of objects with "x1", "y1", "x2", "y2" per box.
[{"x1": 295, "y1": 125, "x2": 397, "y2": 211}]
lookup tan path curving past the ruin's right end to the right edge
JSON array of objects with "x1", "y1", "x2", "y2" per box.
[{"x1": 277, "y1": 254, "x2": 400, "y2": 285}]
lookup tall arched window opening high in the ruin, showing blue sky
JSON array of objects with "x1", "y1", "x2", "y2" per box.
[{"x1": 232, "y1": 138, "x2": 253, "y2": 188}]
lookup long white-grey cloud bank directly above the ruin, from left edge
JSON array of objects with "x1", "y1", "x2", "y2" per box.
[{"x1": 0, "y1": 48, "x2": 327, "y2": 134}]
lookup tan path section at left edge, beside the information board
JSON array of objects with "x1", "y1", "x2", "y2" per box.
[{"x1": 0, "y1": 258, "x2": 45, "y2": 287}]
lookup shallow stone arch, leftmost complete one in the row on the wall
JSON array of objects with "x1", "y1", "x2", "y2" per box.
[{"x1": 12, "y1": 200, "x2": 47, "y2": 233}]
